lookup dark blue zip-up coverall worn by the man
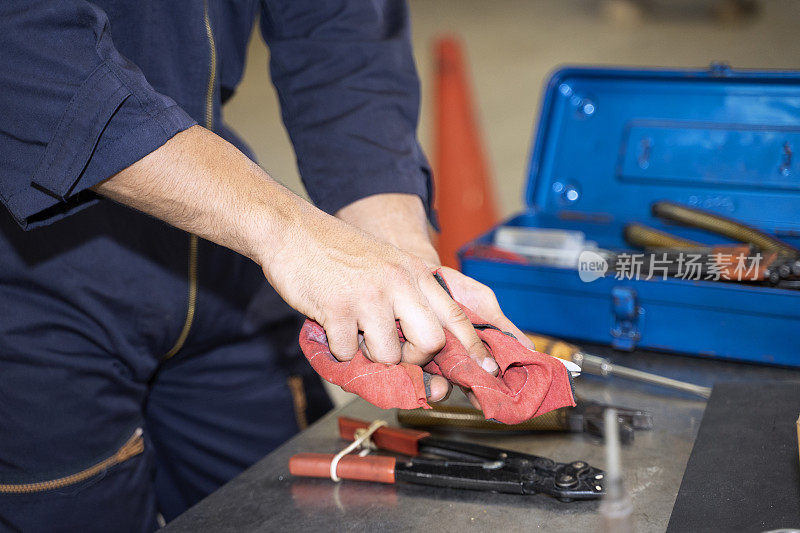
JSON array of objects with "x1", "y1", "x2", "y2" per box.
[{"x1": 0, "y1": 0, "x2": 431, "y2": 531}]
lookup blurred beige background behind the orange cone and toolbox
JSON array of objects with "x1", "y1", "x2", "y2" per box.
[{"x1": 225, "y1": 0, "x2": 800, "y2": 216}]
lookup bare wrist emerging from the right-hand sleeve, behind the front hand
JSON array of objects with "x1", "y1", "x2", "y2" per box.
[{"x1": 336, "y1": 193, "x2": 441, "y2": 267}]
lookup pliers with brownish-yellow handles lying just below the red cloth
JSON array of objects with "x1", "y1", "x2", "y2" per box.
[{"x1": 397, "y1": 398, "x2": 653, "y2": 444}]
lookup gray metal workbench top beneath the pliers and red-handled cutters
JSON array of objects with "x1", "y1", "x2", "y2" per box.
[{"x1": 165, "y1": 346, "x2": 800, "y2": 533}]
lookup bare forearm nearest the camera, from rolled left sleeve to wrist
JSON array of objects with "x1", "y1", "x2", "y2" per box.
[{"x1": 94, "y1": 126, "x2": 310, "y2": 266}]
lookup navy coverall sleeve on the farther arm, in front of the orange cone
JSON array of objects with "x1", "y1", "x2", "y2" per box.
[{"x1": 261, "y1": 0, "x2": 433, "y2": 218}]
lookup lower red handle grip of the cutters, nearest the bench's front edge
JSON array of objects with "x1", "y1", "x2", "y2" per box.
[{"x1": 289, "y1": 453, "x2": 397, "y2": 483}]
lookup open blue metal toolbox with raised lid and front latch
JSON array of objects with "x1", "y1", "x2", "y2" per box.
[{"x1": 460, "y1": 65, "x2": 800, "y2": 366}]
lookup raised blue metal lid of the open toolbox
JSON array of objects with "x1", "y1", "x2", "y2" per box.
[{"x1": 525, "y1": 64, "x2": 800, "y2": 235}]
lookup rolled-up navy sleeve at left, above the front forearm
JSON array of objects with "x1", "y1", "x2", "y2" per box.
[{"x1": 0, "y1": 0, "x2": 194, "y2": 229}]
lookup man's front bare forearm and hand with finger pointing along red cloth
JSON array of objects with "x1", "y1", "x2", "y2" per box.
[{"x1": 94, "y1": 126, "x2": 497, "y2": 401}]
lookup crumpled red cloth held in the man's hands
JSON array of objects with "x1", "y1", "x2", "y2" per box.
[{"x1": 300, "y1": 272, "x2": 575, "y2": 424}]
